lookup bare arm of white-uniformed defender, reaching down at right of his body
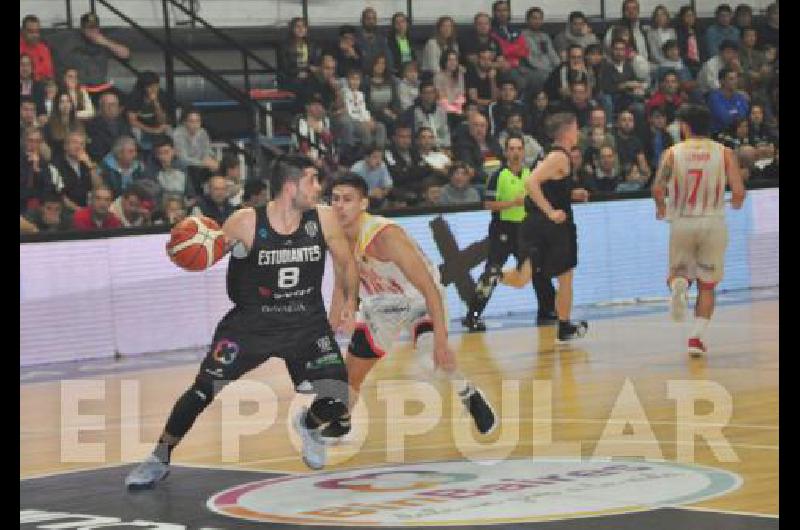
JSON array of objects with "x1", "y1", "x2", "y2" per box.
[{"x1": 369, "y1": 225, "x2": 455, "y2": 371}]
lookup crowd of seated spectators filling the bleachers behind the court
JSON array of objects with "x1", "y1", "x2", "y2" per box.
[{"x1": 20, "y1": 0, "x2": 778, "y2": 233}]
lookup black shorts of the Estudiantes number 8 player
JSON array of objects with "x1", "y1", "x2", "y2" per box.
[{"x1": 198, "y1": 313, "x2": 347, "y2": 393}]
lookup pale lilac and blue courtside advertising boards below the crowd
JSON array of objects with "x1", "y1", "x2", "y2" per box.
[{"x1": 20, "y1": 188, "x2": 778, "y2": 365}]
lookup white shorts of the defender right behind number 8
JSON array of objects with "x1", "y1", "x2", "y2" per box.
[{"x1": 349, "y1": 293, "x2": 433, "y2": 359}]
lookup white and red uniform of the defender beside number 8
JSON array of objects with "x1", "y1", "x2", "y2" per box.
[{"x1": 355, "y1": 212, "x2": 444, "y2": 357}]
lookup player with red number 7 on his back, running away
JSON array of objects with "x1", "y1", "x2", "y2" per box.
[{"x1": 652, "y1": 105, "x2": 745, "y2": 356}]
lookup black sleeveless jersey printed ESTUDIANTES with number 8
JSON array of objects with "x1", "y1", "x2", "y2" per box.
[{"x1": 226, "y1": 206, "x2": 328, "y2": 342}]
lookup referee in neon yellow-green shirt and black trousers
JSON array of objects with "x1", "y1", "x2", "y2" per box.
[{"x1": 461, "y1": 134, "x2": 557, "y2": 331}]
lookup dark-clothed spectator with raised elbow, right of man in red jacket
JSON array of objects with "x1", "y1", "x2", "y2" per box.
[{"x1": 57, "y1": 13, "x2": 131, "y2": 94}]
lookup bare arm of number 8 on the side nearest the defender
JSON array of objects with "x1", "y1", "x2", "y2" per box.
[{"x1": 317, "y1": 206, "x2": 358, "y2": 329}]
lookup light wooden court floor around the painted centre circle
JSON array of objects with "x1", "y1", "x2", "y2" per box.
[{"x1": 20, "y1": 298, "x2": 779, "y2": 528}]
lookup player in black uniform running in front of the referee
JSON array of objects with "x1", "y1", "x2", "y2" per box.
[{"x1": 501, "y1": 112, "x2": 589, "y2": 343}]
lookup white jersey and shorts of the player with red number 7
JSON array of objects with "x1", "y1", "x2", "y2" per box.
[{"x1": 667, "y1": 138, "x2": 728, "y2": 286}]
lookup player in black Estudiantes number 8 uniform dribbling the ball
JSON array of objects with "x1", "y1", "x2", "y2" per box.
[{"x1": 125, "y1": 154, "x2": 358, "y2": 488}]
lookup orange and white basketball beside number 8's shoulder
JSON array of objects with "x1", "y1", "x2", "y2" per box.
[{"x1": 167, "y1": 217, "x2": 225, "y2": 271}]
